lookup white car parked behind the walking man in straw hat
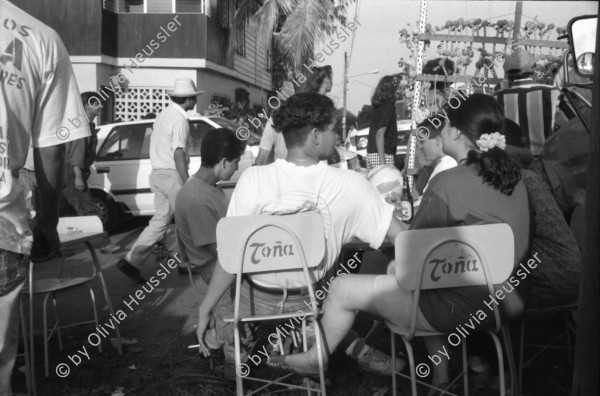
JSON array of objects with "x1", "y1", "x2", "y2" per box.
[{"x1": 88, "y1": 117, "x2": 260, "y2": 230}]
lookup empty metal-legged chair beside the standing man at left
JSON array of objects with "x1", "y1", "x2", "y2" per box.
[{"x1": 23, "y1": 216, "x2": 123, "y2": 380}]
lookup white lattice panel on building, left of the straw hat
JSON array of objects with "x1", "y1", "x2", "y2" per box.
[{"x1": 115, "y1": 87, "x2": 169, "y2": 122}]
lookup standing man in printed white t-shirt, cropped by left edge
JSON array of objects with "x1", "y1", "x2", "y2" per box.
[{"x1": 0, "y1": 0, "x2": 90, "y2": 395}]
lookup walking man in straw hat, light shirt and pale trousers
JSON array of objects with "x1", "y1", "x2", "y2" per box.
[{"x1": 117, "y1": 78, "x2": 204, "y2": 283}]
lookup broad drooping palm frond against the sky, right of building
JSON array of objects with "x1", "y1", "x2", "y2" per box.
[{"x1": 277, "y1": 0, "x2": 332, "y2": 66}]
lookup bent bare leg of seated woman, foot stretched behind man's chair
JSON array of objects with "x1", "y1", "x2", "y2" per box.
[{"x1": 274, "y1": 274, "x2": 380, "y2": 374}]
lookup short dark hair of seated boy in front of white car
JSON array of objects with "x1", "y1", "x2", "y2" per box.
[{"x1": 200, "y1": 128, "x2": 246, "y2": 168}]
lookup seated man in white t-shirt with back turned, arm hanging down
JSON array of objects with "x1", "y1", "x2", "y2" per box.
[{"x1": 197, "y1": 93, "x2": 404, "y2": 374}]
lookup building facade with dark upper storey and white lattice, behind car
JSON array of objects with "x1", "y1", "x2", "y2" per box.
[{"x1": 11, "y1": 0, "x2": 273, "y2": 123}]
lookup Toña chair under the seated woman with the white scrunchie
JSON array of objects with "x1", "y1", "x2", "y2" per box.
[{"x1": 388, "y1": 224, "x2": 517, "y2": 396}]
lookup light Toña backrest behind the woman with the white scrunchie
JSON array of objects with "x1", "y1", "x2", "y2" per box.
[{"x1": 395, "y1": 224, "x2": 515, "y2": 334}]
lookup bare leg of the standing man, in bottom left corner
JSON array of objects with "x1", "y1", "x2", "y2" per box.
[{"x1": 0, "y1": 282, "x2": 25, "y2": 396}]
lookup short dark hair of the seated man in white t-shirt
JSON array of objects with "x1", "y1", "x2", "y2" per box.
[{"x1": 273, "y1": 92, "x2": 336, "y2": 149}]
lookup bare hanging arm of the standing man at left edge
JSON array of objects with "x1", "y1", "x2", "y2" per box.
[{"x1": 32, "y1": 144, "x2": 65, "y2": 254}]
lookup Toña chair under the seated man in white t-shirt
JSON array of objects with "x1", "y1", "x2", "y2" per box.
[{"x1": 217, "y1": 212, "x2": 326, "y2": 396}]
